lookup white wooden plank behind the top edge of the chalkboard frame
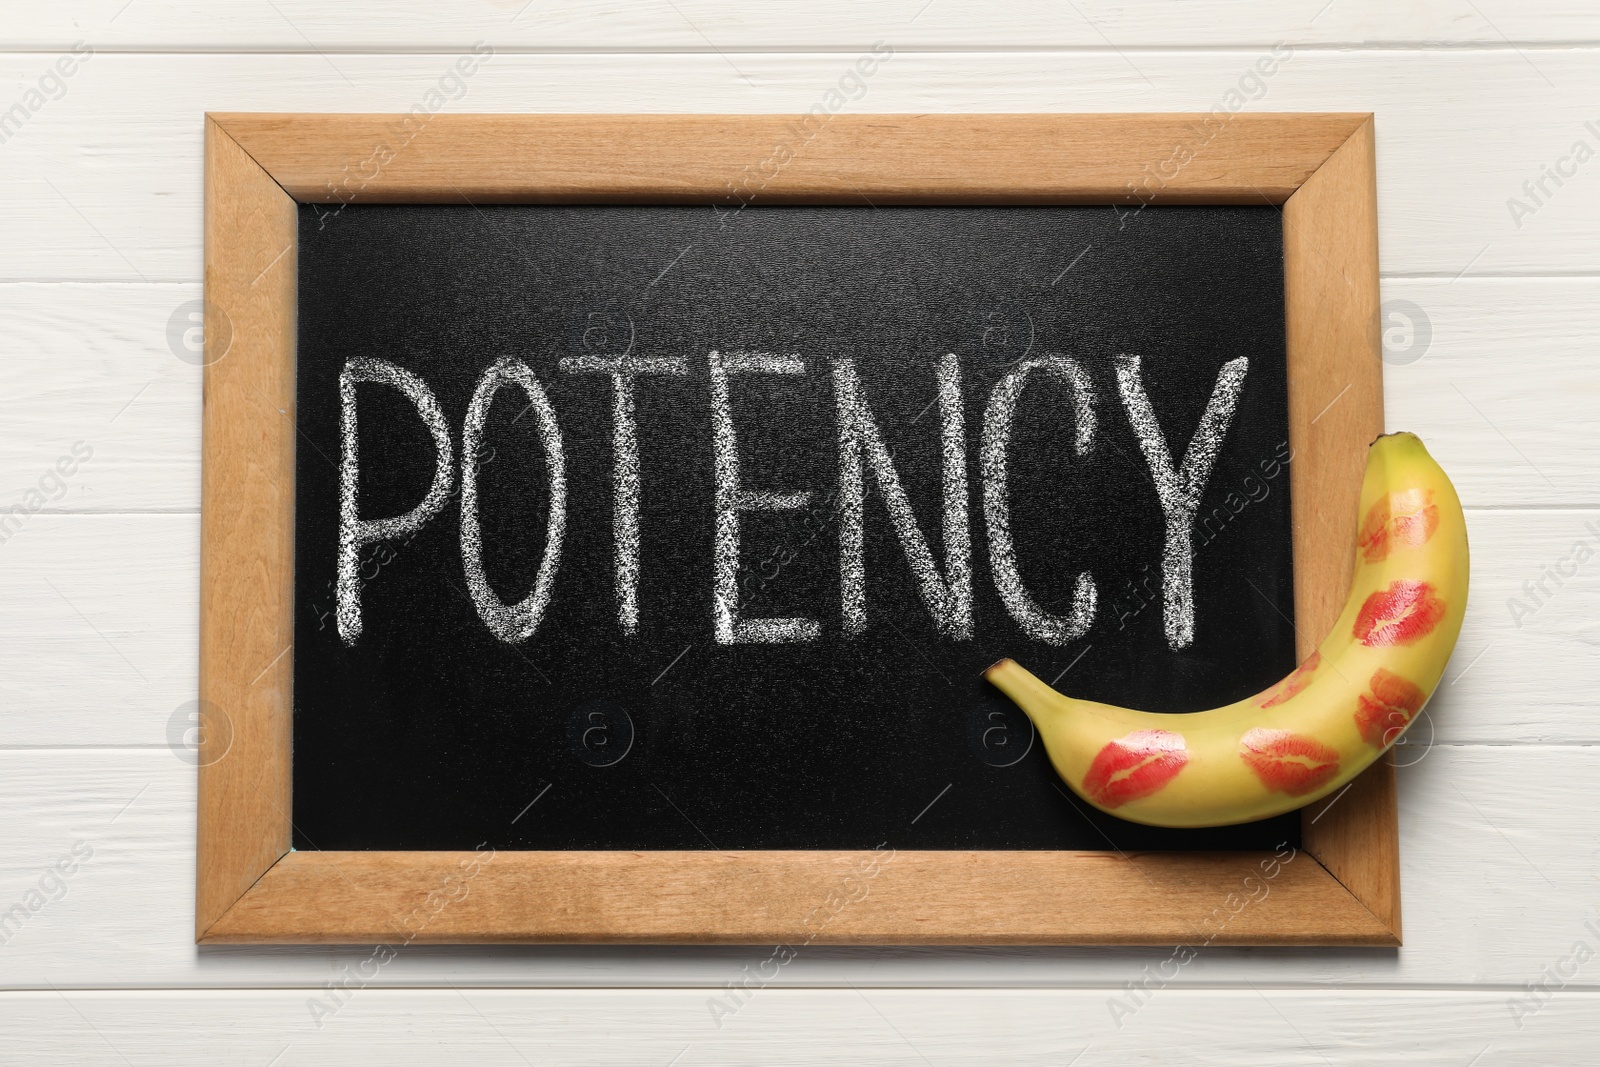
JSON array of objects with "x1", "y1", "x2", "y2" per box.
[{"x1": 0, "y1": 51, "x2": 1600, "y2": 278}]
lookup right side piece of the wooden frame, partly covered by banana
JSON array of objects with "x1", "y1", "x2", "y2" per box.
[{"x1": 1283, "y1": 118, "x2": 1400, "y2": 937}]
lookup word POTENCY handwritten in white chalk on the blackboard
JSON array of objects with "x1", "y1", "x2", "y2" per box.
[{"x1": 334, "y1": 350, "x2": 1250, "y2": 649}]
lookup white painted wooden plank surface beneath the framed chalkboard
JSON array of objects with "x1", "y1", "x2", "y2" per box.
[{"x1": 0, "y1": 0, "x2": 1600, "y2": 1067}]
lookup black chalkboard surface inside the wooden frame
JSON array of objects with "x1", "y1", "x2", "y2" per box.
[{"x1": 293, "y1": 205, "x2": 1299, "y2": 849}]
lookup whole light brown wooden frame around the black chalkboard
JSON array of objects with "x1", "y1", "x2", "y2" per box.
[{"x1": 195, "y1": 110, "x2": 1400, "y2": 945}]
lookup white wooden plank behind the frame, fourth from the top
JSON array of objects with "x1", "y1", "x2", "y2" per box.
[{"x1": 0, "y1": 511, "x2": 1600, "y2": 751}]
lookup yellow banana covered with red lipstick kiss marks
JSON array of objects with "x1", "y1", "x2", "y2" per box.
[{"x1": 984, "y1": 434, "x2": 1467, "y2": 827}]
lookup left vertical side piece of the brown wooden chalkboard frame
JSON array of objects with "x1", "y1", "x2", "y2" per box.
[{"x1": 195, "y1": 122, "x2": 296, "y2": 936}]
